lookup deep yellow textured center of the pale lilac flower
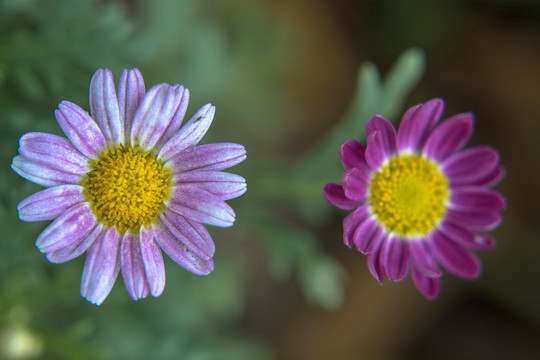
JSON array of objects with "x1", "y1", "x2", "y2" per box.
[{"x1": 81, "y1": 145, "x2": 172, "y2": 234}]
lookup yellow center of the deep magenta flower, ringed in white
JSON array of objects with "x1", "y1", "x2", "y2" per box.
[{"x1": 368, "y1": 154, "x2": 449, "y2": 237}]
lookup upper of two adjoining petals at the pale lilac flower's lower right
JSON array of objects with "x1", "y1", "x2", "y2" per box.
[{"x1": 159, "y1": 211, "x2": 216, "y2": 259}]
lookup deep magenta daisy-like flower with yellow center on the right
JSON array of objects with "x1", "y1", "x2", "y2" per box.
[{"x1": 323, "y1": 99, "x2": 505, "y2": 299}]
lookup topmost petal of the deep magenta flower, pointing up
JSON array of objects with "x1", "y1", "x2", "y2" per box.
[{"x1": 397, "y1": 98, "x2": 444, "y2": 152}]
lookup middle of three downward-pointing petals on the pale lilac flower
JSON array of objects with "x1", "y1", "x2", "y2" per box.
[{"x1": 120, "y1": 232, "x2": 149, "y2": 300}]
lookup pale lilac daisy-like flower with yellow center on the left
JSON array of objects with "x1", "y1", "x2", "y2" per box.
[{"x1": 11, "y1": 69, "x2": 246, "y2": 305}]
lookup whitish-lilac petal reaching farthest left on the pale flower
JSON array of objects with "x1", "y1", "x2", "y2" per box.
[{"x1": 11, "y1": 155, "x2": 81, "y2": 187}]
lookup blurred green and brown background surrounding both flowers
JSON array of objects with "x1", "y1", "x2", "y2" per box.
[{"x1": 0, "y1": 0, "x2": 540, "y2": 360}]
